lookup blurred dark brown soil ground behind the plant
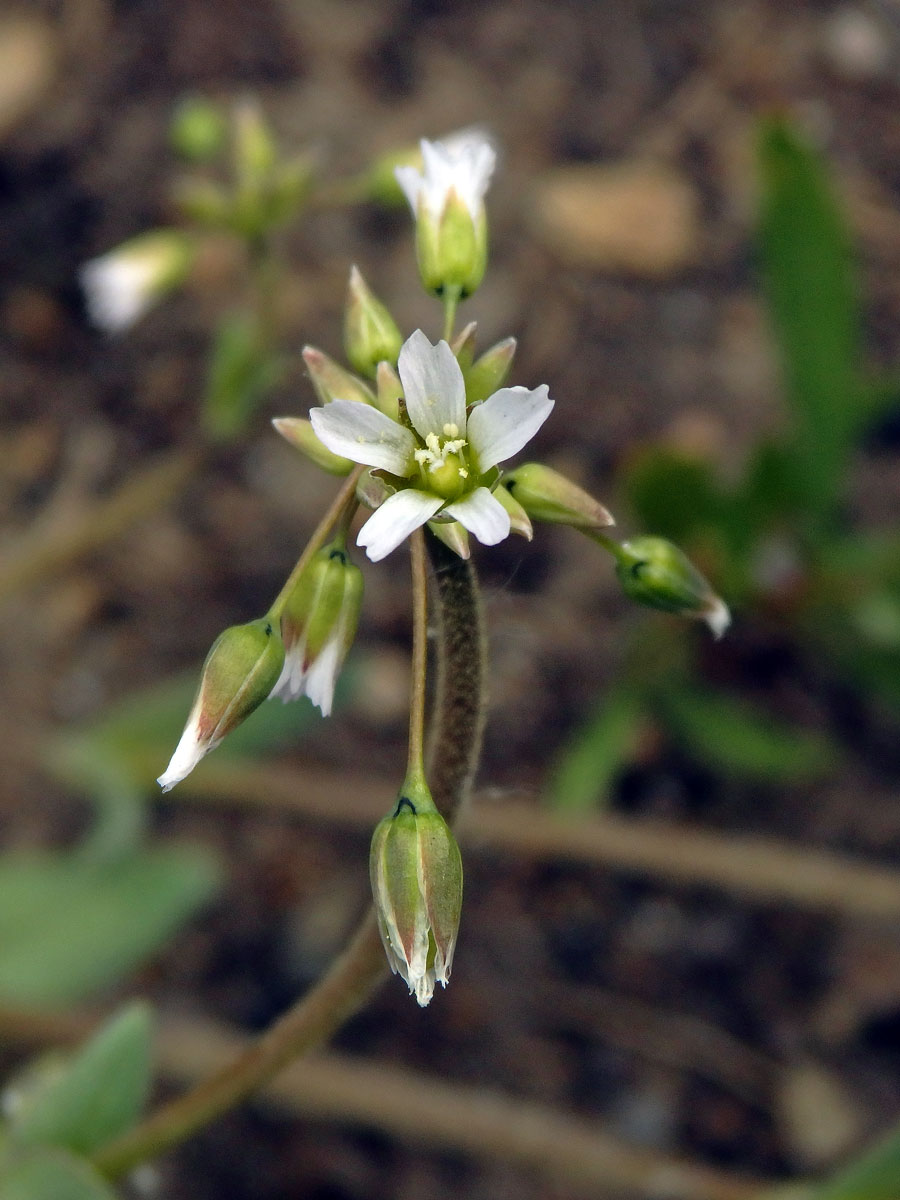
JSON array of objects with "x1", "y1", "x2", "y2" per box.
[{"x1": 0, "y1": 0, "x2": 900, "y2": 1200}]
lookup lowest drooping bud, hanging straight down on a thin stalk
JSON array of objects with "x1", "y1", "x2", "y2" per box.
[{"x1": 370, "y1": 779, "x2": 462, "y2": 1007}]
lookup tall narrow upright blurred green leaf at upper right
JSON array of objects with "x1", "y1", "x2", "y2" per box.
[{"x1": 760, "y1": 118, "x2": 864, "y2": 530}]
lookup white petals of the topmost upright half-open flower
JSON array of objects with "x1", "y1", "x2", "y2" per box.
[{"x1": 394, "y1": 128, "x2": 497, "y2": 221}]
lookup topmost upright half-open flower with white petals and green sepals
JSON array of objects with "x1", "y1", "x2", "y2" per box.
[{"x1": 395, "y1": 130, "x2": 497, "y2": 296}]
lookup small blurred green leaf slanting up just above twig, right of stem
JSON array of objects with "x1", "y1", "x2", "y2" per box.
[{"x1": 547, "y1": 686, "x2": 642, "y2": 812}]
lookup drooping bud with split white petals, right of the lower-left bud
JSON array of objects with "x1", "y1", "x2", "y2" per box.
[{"x1": 272, "y1": 540, "x2": 362, "y2": 716}]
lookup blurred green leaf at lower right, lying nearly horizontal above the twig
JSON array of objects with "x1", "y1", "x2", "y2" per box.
[{"x1": 659, "y1": 688, "x2": 838, "y2": 784}]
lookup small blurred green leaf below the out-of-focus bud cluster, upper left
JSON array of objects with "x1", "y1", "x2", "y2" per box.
[{"x1": 203, "y1": 314, "x2": 283, "y2": 442}]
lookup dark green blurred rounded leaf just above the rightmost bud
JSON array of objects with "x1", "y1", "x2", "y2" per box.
[{"x1": 625, "y1": 446, "x2": 722, "y2": 542}]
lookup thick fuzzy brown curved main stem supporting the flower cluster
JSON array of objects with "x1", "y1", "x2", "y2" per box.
[{"x1": 94, "y1": 528, "x2": 485, "y2": 1178}]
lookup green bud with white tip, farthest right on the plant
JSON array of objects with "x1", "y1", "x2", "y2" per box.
[{"x1": 616, "y1": 535, "x2": 731, "y2": 637}]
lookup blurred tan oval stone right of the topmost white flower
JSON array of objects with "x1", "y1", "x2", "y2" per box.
[{"x1": 532, "y1": 162, "x2": 698, "y2": 277}]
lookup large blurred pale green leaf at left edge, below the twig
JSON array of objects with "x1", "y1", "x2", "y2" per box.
[{"x1": 0, "y1": 845, "x2": 218, "y2": 1006}]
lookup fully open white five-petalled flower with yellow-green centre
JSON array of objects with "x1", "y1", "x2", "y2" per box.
[{"x1": 310, "y1": 330, "x2": 553, "y2": 563}]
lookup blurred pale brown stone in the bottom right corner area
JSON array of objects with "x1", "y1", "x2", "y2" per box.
[{"x1": 776, "y1": 1062, "x2": 865, "y2": 1170}]
